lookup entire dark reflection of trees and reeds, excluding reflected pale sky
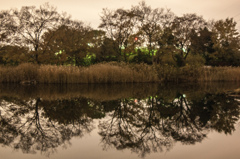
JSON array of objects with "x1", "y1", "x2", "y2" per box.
[{"x1": 0, "y1": 84, "x2": 240, "y2": 157}]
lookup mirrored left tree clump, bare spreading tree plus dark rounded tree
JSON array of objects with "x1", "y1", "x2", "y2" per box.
[{"x1": 0, "y1": 98, "x2": 102, "y2": 155}]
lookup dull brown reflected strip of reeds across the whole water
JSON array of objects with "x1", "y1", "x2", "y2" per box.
[{"x1": 0, "y1": 82, "x2": 240, "y2": 101}]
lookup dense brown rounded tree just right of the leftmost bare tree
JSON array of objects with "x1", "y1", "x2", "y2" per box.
[{"x1": 43, "y1": 20, "x2": 94, "y2": 65}]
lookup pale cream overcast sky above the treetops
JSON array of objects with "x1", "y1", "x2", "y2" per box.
[{"x1": 0, "y1": 0, "x2": 240, "y2": 30}]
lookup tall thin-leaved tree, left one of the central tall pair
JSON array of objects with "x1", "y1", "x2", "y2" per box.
[{"x1": 99, "y1": 9, "x2": 137, "y2": 61}]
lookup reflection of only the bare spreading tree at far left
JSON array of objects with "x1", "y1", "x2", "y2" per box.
[{"x1": 0, "y1": 98, "x2": 86, "y2": 155}]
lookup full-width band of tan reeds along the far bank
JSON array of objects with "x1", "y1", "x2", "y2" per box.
[{"x1": 0, "y1": 62, "x2": 240, "y2": 84}]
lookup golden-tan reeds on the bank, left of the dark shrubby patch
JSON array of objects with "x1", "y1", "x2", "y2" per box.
[{"x1": 0, "y1": 62, "x2": 158, "y2": 84}]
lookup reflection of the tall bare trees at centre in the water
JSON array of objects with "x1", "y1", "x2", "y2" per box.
[{"x1": 99, "y1": 99, "x2": 171, "y2": 156}]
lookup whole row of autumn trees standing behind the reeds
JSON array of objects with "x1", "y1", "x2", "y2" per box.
[{"x1": 0, "y1": 1, "x2": 240, "y2": 67}]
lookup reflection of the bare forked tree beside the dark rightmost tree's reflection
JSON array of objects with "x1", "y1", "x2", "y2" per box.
[{"x1": 160, "y1": 93, "x2": 207, "y2": 144}]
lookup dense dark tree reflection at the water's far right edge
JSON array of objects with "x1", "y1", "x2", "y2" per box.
[{"x1": 193, "y1": 93, "x2": 240, "y2": 134}]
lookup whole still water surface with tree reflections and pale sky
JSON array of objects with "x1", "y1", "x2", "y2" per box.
[{"x1": 0, "y1": 83, "x2": 240, "y2": 159}]
